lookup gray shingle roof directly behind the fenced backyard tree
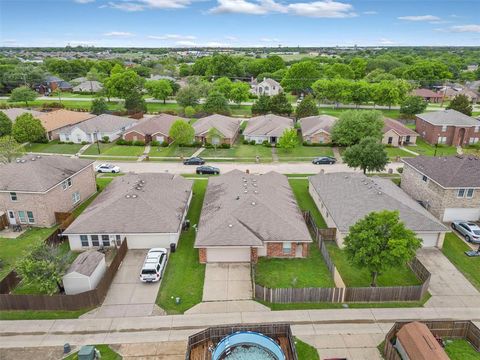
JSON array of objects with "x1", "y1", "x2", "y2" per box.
[{"x1": 309, "y1": 173, "x2": 447, "y2": 232}]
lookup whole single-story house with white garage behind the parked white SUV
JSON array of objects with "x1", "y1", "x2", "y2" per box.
[{"x1": 63, "y1": 173, "x2": 192, "y2": 250}]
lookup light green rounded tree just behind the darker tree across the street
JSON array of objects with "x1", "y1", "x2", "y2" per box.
[{"x1": 332, "y1": 110, "x2": 384, "y2": 146}]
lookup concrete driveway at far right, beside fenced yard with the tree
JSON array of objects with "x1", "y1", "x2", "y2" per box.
[{"x1": 417, "y1": 248, "x2": 480, "y2": 307}]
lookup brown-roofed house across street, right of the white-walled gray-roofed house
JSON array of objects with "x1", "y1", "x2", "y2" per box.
[{"x1": 123, "y1": 114, "x2": 188, "y2": 143}]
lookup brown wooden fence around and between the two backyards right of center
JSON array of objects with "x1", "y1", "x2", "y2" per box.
[{"x1": 254, "y1": 212, "x2": 431, "y2": 304}]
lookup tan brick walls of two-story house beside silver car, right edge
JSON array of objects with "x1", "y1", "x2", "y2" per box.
[{"x1": 400, "y1": 164, "x2": 480, "y2": 220}]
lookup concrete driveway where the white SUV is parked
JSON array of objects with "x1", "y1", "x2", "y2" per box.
[{"x1": 85, "y1": 250, "x2": 160, "y2": 318}]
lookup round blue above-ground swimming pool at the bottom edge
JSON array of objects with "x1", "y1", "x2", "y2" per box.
[{"x1": 212, "y1": 331, "x2": 285, "y2": 360}]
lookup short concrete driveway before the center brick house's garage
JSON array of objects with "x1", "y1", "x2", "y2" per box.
[{"x1": 203, "y1": 263, "x2": 252, "y2": 301}]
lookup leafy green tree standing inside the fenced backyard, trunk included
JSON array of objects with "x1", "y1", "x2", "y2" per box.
[{"x1": 344, "y1": 210, "x2": 421, "y2": 286}]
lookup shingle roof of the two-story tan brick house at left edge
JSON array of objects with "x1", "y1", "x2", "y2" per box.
[{"x1": 0, "y1": 155, "x2": 93, "y2": 192}]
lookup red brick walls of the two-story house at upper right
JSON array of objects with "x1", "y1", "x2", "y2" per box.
[{"x1": 415, "y1": 117, "x2": 480, "y2": 146}]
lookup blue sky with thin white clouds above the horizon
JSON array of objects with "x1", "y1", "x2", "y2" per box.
[{"x1": 0, "y1": 0, "x2": 480, "y2": 47}]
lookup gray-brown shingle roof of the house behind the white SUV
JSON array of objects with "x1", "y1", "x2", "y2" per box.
[{"x1": 64, "y1": 173, "x2": 192, "y2": 234}]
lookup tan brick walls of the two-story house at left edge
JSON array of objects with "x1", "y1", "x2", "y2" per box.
[{"x1": 0, "y1": 165, "x2": 97, "y2": 227}]
